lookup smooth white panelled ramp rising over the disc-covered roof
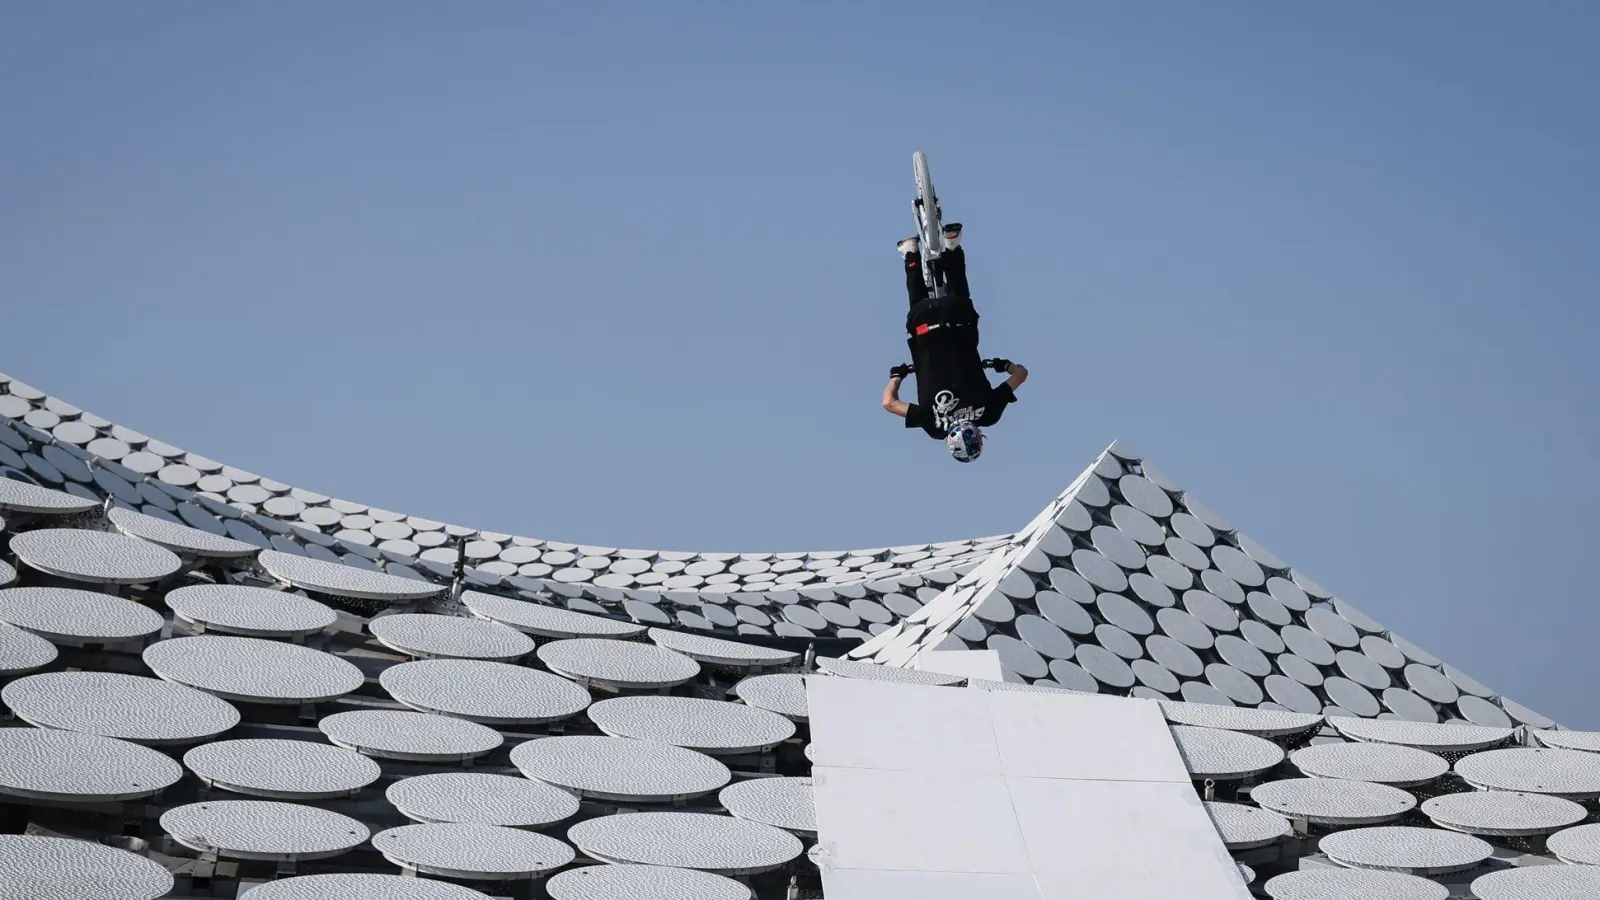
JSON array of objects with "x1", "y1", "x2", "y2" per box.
[{"x1": 806, "y1": 676, "x2": 1250, "y2": 900}]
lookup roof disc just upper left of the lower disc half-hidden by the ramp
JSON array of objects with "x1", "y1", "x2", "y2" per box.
[{"x1": 510, "y1": 735, "x2": 733, "y2": 802}]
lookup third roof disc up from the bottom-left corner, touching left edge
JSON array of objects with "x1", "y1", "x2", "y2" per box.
[{"x1": 0, "y1": 671, "x2": 240, "y2": 745}]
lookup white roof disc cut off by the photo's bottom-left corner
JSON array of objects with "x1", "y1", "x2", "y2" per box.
[{"x1": 0, "y1": 832, "x2": 173, "y2": 900}]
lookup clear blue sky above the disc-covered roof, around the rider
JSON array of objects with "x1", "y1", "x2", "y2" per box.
[{"x1": 0, "y1": 0, "x2": 1600, "y2": 729}]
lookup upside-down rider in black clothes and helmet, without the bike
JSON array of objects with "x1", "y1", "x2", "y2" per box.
[{"x1": 883, "y1": 223, "x2": 1027, "y2": 463}]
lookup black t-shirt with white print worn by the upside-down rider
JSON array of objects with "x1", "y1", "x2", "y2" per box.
[{"x1": 906, "y1": 298, "x2": 1016, "y2": 440}]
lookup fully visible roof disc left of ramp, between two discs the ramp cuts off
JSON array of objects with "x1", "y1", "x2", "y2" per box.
[{"x1": 589, "y1": 695, "x2": 795, "y2": 754}]
